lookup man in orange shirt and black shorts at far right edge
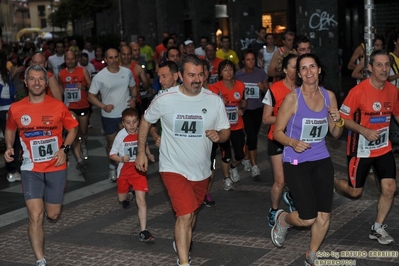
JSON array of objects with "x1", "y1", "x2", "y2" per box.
[{"x1": 334, "y1": 50, "x2": 399, "y2": 245}]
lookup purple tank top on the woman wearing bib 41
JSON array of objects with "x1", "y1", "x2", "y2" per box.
[{"x1": 283, "y1": 87, "x2": 330, "y2": 165}]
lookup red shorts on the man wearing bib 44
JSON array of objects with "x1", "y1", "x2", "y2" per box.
[{"x1": 160, "y1": 172, "x2": 209, "y2": 216}]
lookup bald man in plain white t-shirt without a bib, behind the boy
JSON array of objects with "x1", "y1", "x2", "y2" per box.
[{"x1": 88, "y1": 48, "x2": 137, "y2": 182}]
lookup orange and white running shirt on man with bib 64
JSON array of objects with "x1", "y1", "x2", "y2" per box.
[{"x1": 7, "y1": 96, "x2": 78, "y2": 173}]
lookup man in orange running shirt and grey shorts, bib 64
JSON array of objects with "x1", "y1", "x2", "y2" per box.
[{"x1": 4, "y1": 65, "x2": 78, "y2": 265}]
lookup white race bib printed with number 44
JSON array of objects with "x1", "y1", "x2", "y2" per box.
[{"x1": 173, "y1": 114, "x2": 205, "y2": 138}]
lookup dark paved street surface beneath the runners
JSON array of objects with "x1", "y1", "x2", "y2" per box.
[{"x1": 0, "y1": 106, "x2": 399, "y2": 266}]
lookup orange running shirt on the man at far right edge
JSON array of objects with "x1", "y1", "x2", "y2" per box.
[{"x1": 340, "y1": 79, "x2": 399, "y2": 158}]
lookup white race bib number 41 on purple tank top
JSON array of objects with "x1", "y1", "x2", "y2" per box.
[{"x1": 301, "y1": 117, "x2": 328, "y2": 143}]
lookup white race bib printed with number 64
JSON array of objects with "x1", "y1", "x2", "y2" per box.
[{"x1": 30, "y1": 137, "x2": 58, "y2": 163}]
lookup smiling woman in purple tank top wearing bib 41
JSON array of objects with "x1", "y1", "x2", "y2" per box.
[{"x1": 271, "y1": 54, "x2": 344, "y2": 265}]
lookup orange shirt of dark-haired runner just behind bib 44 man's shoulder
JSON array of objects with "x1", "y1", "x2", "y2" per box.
[{"x1": 209, "y1": 80, "x2": 245, "y2": 131}]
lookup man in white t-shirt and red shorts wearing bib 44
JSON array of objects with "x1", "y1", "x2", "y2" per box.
[{"x1": 136, "y1": 55, "x2": 230, "y2": 266}]
